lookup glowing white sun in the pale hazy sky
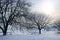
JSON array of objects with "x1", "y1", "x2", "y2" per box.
[{"x1": 42, "y1": 2, "x2": 54, "y2": 15}]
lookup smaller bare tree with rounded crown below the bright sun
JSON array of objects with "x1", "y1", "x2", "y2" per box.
[{"x1": 26, "y1": 14, "x2": 51, "y2": 34}]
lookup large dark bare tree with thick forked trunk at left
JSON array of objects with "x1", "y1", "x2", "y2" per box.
[{"x1": 0, "y1": 0, "x2": 31, "y2": 35}]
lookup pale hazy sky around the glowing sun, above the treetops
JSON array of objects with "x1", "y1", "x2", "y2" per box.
[{"x1": 30, "y1": 0, "x2": 60, "y2": 17}]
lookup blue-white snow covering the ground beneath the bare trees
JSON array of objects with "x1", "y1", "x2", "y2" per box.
[{"x1": 0, "y1": 31, "x2": 60, "y2": 40}]
